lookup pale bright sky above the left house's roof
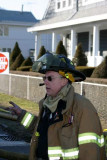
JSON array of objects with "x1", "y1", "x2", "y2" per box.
[{"x1": 0, "y1": 0, "x2": 49, "y2": 19}]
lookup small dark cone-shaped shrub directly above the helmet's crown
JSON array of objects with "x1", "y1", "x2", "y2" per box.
[{"x1": 56, "y1": 41, "x2": 67, "y2": 57}]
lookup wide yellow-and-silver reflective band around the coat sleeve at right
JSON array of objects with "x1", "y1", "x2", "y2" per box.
[{"x1": 78, "y1": 132, "x2": 104, "y2": 147}]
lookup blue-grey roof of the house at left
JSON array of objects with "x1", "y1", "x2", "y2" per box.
[{"x1": 0, "y1": 10, "x2": 38, "y2": 23}]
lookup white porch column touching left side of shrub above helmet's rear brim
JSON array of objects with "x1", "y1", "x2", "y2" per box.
[{"x1": 69, "y1": 29, "x2": 76, "y2": 60}]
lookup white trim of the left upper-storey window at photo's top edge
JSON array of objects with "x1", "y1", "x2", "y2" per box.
[{"x1": 55, "y1": 0, "x2": 73, "y2": 12}]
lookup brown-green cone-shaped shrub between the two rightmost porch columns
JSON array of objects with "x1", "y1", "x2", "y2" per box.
[{"x1": 72, "y1": 43, "x2": 88, "y2": 66}]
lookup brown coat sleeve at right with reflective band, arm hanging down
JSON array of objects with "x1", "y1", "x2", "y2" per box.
[{"x1": 78, "y1": 99, "x2": 105, "y2": 160}]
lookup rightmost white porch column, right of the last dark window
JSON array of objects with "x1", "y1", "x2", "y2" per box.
[{"x1": 92, "y1": 25, "x2": 99, "y2": 66}]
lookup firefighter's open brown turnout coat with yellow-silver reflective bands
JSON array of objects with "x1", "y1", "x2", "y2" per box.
[{"x1": 19, "y1": 86, "x2": 105, "y2": 160}]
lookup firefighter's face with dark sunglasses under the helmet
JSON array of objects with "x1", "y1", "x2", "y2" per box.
[{"x1": 43, "y1": 71, "x2": 68, "y2": 97}]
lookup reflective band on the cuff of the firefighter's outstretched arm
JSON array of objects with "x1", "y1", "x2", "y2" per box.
[{"x1": 21, "y1": 112, "x2": 34, "y2": 128}]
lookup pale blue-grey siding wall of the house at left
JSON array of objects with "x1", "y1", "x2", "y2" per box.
[{"x1": 0, "y1": 25, "x2": 35, "y2": 58}]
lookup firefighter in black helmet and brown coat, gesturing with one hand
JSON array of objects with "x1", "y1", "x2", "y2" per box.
[{"x1": 10, "y1": 53, "x2": 105, "y2": 160}]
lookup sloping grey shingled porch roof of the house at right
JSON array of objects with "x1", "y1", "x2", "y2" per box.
[{"x1": 28, "y1": 0, "x2": 107, "y2": 31}]
